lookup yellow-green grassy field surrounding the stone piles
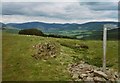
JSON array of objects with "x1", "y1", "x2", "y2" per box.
[{"x1": 2, "y1": 33, "x2": 118, "y2": 81}]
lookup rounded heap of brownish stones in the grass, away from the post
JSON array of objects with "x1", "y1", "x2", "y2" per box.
[{"x1": 32, "y1": 42, "x2": 59, "y2": 60}]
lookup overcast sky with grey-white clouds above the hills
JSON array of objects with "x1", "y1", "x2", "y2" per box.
[{"x1": 0, "y1": 0, "x2": 118, "y2": 23}]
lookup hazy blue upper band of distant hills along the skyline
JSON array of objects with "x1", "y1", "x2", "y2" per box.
[{"x1": 3, "y1": 22, "x2": 118, "y2": 32}]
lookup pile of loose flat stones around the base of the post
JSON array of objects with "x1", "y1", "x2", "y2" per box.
[{"x1": 68, "y1": 62, "x2": 118, "y2": 82}]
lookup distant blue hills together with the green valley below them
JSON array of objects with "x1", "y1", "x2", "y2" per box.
[{"x1": 0, "y1": 22, "x2": 119, "y2": 39}]
